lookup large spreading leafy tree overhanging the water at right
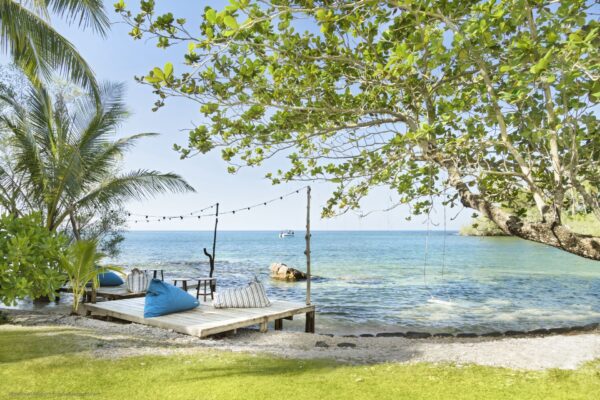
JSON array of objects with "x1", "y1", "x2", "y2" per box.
[{"x1": 115, "y1": 0, "x2": 600, "y2": 260}]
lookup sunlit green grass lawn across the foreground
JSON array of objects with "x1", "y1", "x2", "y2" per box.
[{"x1": 0, "y1": 325, "x2": 600, "y2": 400}]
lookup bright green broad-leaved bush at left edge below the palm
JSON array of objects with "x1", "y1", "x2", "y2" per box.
[{"x1": 0, "y1": 213, "x2": 68, "y2": 305}]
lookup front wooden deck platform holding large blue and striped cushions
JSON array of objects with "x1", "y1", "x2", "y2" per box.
[{"x1": 85, "y1": 298, "x2": 315, "y2": 338}]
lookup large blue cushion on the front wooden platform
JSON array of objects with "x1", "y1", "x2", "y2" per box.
[{"x1": 144, "y1": 279, "x2": 200, "y2": 318}]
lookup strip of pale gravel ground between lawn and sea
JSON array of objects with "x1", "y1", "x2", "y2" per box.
[{"x1": 0, "y1": 310, "x2": 600, "y2": 370}]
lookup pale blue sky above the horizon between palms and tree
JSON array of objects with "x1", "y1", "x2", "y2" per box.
[{"x1": 44, "y1": 0, "x2": 472, "y2": 230}]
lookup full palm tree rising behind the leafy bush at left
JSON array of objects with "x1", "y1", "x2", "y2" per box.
[{"x1": 0, "y1": 84, "x2": 194, "y2": 238}]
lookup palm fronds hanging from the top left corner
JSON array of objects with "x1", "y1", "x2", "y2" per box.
[{"x1": 0, "y1": 0, "x2": 109, "y2": 95}]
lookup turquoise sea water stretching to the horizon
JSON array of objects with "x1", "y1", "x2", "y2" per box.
[{"x1": 109, "y1": 231, "x2": 600, "y2": 333}]
